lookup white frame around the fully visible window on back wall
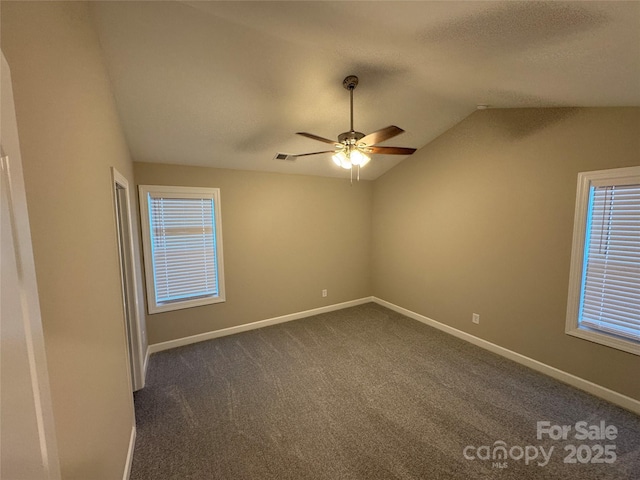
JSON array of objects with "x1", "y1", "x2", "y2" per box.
[{"x1": 138, "y1": 185, "x2": 226, "y2": 314}]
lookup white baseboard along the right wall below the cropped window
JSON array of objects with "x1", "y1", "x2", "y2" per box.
[{"x1": 372, "y1": 297, "x2": 640, "y2": 415}]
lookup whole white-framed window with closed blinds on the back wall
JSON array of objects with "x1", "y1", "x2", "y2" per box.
[{"x1": 139, "y1": 185, "x2": 225, "y2": 313}]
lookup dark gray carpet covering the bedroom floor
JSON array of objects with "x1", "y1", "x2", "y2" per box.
[{"x1": 131, "y1": 303, "x2": 640, "y2": 480}]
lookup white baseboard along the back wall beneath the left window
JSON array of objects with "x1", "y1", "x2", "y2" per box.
[{"x1": 147, "y1": 297, "x2": 374, "y2": 357}]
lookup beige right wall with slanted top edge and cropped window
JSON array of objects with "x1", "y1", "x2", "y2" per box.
[{"x1": 372, "y1": 108, "x2": 640, "y2": 400}]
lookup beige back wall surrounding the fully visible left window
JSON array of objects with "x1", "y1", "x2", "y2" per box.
[{"x1": 134, "y1": 162, "x2": 372, "y2": 344}]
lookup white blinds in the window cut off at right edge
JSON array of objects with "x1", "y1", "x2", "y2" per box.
[{"x1": 579, "y1": 185, "x2": 640, "y2": 342}]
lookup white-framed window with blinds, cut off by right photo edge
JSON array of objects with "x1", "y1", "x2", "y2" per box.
[{"x1": 566, "y1": 167, "x2": 640, "y2": 355}]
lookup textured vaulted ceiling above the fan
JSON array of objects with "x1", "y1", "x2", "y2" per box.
[{"x1": 91, "y1": 1, "x2": 640, "y2": 179}]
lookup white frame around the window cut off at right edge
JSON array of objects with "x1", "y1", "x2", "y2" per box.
[{"x1": 565, "y1": 166, "x2": 640, "y2": 355}]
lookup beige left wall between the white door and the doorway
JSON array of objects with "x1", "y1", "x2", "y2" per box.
[{"x1": 1, "y1": 1, "x2": 139, "y2": 480}]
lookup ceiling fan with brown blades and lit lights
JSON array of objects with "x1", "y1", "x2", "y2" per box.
[{"x1": 276, "y1": 75, "x2": 416, "y2": 177}]
